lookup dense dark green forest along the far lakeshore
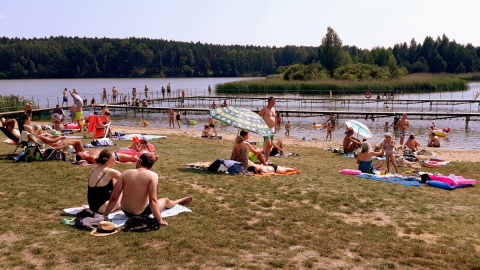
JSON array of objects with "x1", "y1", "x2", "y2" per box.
[{"x1": 0, "y1": 27, "x2": 480, "y2": 79}]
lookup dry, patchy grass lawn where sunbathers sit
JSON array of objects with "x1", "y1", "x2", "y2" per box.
[{"x1": 0, "y1": 134, "x2": 480, "y2": 269}]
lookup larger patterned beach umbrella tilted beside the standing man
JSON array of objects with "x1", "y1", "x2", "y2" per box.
[{"x1": 210, "y1": 106, "x2": 273, "y2": 135}]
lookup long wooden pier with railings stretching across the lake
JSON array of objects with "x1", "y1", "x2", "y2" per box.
[{"x1": 0, "y1": 96, "x2": 480, "y2": 128}]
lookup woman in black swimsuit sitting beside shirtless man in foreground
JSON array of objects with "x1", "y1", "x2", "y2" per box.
[{"x1": 87, "y1": 149, "x2": 121, "y2": 214}]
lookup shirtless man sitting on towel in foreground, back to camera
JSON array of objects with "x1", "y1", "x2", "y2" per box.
[{"x1": 104, "y1": 153, "x2": 193, "y2": 226}]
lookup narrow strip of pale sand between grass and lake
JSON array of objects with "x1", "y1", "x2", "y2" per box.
[{"x1": 109, "y1": 126, "x2": 480, "y2": 162}]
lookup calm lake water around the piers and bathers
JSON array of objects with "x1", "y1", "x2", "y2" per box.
[{"x1": 0, "y1": 78, "x2": 480, "y2": 149}]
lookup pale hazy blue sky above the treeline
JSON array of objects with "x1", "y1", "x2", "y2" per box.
[{"x1": 0, "y1": 0, "x2": 480, "y2": 49}]
